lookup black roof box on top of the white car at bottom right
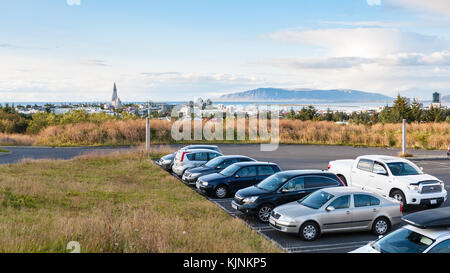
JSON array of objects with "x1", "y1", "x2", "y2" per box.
[{"x1": 402, "y1": 208, "x2": 450, "y2": 229}]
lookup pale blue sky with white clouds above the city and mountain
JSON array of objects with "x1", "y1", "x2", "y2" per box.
[{"x1": 0, "y1": 0, "x2": 450, "y2": 102}]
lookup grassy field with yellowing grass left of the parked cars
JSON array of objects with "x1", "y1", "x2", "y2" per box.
[{"x1": 0, "y1": 150, "x2": 280, "y2": 253}]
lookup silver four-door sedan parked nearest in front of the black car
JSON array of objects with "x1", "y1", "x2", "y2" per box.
[{"x1": 269, "y1": 187, "x2": 402, "y2": 241}]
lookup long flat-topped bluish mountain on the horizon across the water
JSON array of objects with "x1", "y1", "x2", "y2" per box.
[{"x1": 218, "y1": 88, "x2": 393, "y2": 102}]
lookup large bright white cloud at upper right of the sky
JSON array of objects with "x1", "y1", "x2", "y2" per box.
[{"x1": 268, "y1": 27, "x2": 449, "y2": 58}]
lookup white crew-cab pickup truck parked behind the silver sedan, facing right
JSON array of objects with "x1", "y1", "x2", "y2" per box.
[{"x1": 328, "y1": 155, "x2": 447, "y2": 208}]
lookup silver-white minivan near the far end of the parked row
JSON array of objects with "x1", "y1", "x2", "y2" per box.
[{"x1": 172, "y1": 149, "x2": 223, "y2": 176}]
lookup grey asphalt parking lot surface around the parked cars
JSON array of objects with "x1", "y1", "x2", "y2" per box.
[{"x1": 156, "y1": 145, "x2": 450, "y2": 253}]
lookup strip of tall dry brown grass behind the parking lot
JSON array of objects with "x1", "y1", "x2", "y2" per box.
[{"x1": 1, "y1": 120, "x2": 450, "y2": 149}]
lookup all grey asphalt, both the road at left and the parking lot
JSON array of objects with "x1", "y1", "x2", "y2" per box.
[{"x1": 0, "y1": 144, "x2": 450, "y2": 253}]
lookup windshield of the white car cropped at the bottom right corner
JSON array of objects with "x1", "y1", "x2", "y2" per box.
[{"x1": 372, "y1": 228, "x2": 434, "y2": 253}]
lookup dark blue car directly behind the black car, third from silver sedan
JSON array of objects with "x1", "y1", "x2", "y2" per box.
[{"x1": 196, "y1": 162, "x2": 280, "y2": 198}]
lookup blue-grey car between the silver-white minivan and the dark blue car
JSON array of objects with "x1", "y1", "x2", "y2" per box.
[{"x1": 182, "y1": 155, "x2": 256, "y2": 184}]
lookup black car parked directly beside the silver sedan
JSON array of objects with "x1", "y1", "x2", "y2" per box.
[{"x1": 232, "y1": 170, "x2": 345, "y2": 222}]
